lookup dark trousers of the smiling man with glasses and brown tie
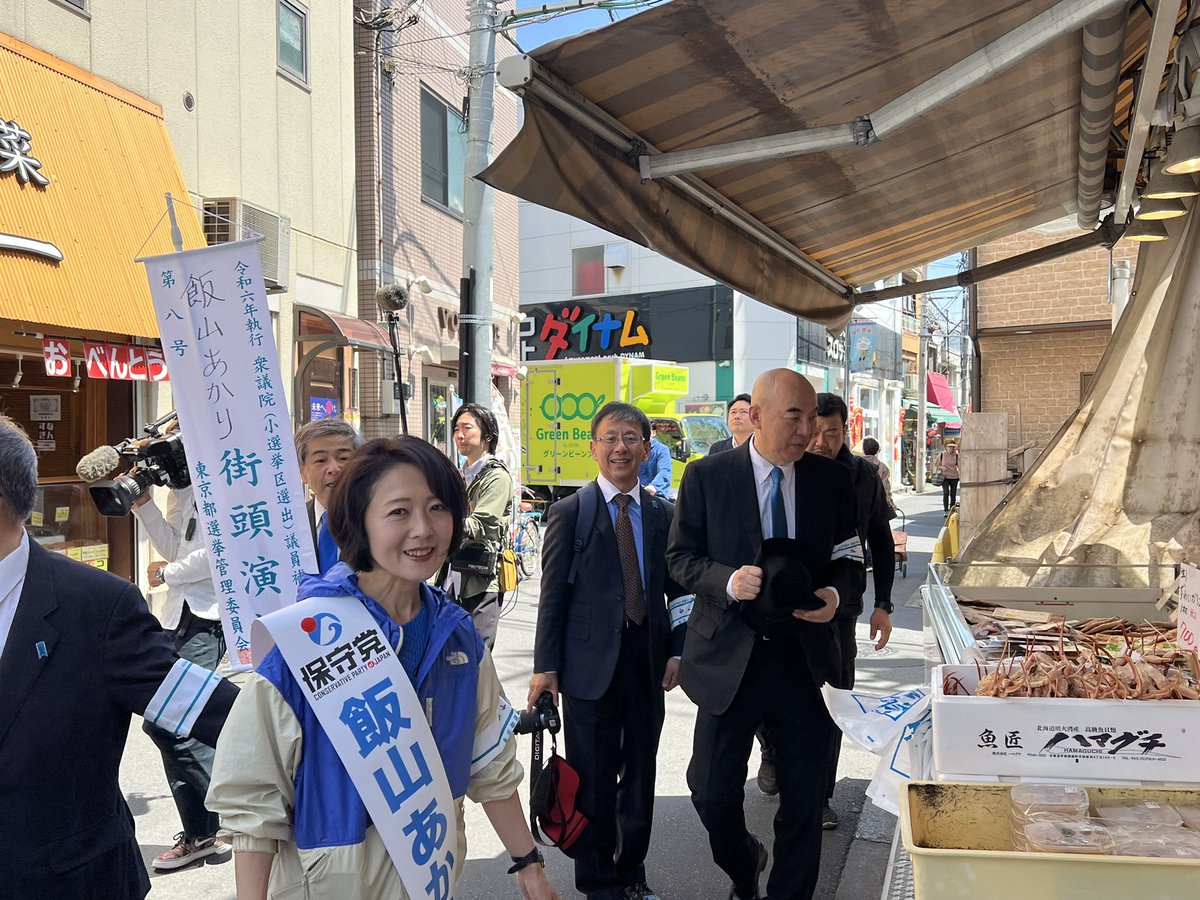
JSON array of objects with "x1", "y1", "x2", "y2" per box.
[{"x1": 563, "y1": 624, "x2": 665, "y2": 900}]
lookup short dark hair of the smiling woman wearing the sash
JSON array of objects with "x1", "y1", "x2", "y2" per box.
[{"x1": 329, "y1": 434, "x2": 468, "y2": 572}]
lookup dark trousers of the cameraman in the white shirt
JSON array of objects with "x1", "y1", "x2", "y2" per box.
[{"x1": 142, "y1": 604, "x2": 226, "y2": 838}]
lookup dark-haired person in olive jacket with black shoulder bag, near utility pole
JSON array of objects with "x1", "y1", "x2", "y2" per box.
[{"x1": 450, "y1": 403, "x2": 514, "y2": 650}]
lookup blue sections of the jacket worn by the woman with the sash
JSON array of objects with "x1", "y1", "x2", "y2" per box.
[{"x1": 258, "y1": 571, "x2": 484, "y2": 850}]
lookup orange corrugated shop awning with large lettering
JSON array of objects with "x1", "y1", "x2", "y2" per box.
[{"x1": 0, "y1": 34, "x2": 205, "y2": 337}]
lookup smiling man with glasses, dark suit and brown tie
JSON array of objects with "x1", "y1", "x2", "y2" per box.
[{"x1": 529, "y1": 403, "x2": 684, "y2": 900}]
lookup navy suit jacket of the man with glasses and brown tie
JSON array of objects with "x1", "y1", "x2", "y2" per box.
[{"x1": 533, "y1": 485, "x2": 683, "y2": 700}]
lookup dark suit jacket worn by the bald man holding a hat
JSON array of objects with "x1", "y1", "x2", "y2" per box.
[{"x1": 667, "y1": 440, "x2": 863, "y2": 715}]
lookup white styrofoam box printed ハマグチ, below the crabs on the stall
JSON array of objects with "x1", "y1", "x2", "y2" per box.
[{"x1": 932, "y1": 665, "x2": 1200, "y2": 784}]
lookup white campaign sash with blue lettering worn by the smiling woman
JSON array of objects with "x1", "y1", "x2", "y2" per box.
[{"x1": 252, "y1": 596, "x2": 458, "y2": 900}]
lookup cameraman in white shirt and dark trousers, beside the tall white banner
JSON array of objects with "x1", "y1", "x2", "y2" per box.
[{"x1": 133, "y1": 487, "x2": 232, "y2": 870}]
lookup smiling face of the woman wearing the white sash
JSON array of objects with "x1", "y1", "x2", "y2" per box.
[{"x1": 364, "y1": 464, "x2": 455, "y2": 583}]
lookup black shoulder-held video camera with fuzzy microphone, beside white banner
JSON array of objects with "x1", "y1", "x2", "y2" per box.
[{"x1": 76, "y1": 410, "x2": 192, "y2": 518}]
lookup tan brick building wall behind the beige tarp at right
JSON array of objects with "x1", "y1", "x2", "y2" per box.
[{"x1": 977, "y1": 225, "x2": 1138, "y2": 448}]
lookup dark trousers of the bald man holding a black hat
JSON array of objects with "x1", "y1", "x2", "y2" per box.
[{"x1": 688, "y1": 638, "x2": 833, "y2": 900}]
